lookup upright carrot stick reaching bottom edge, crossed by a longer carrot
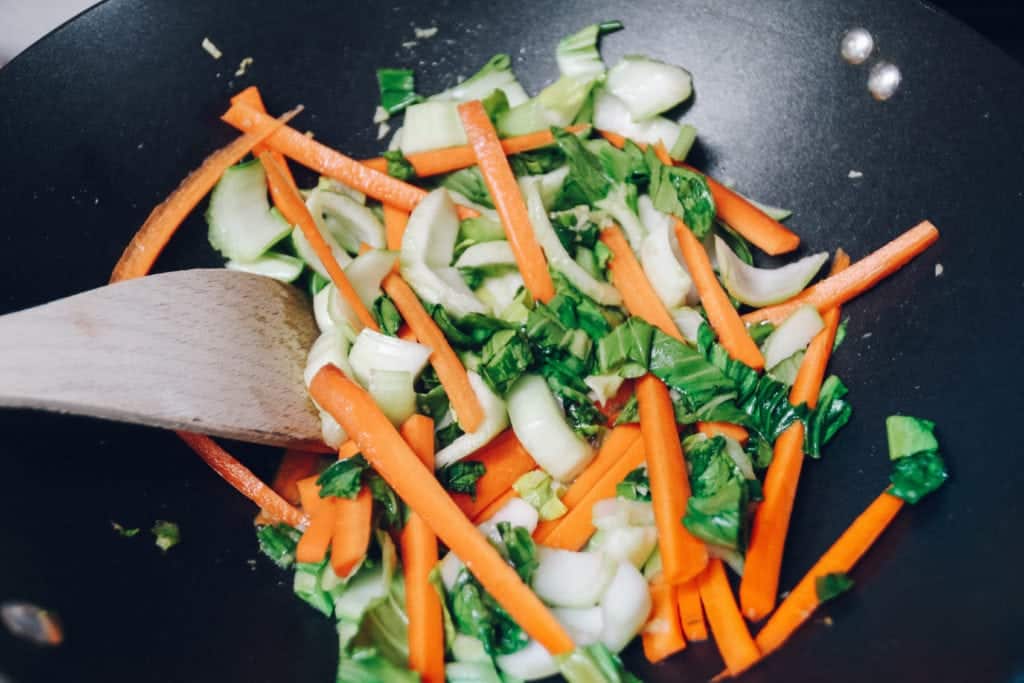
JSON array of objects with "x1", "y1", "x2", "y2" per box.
[{"x1": 399, "y1": 415, "x2": 444, "y2": 683}]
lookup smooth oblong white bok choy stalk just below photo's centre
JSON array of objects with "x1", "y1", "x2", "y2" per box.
[{"x1": 508, "y1": 375, "x2": 594, "y2": 481}]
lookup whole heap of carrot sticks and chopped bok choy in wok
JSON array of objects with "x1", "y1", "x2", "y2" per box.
[{"x1": 112, "y1": 22, "x2": 947, "y2": 683}]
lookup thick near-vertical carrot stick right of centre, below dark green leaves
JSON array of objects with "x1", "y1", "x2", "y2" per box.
[{"x1": 637, "y1": 375, "x2": 708, "y2": 584}]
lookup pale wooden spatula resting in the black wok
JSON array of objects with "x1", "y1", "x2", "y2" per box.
[{"x1": 0, "y1": 269, "x2": 323, "y2": 447}]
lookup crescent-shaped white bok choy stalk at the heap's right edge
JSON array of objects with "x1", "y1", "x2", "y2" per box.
[{"x1": 715, "y1": 236, "x2": 828, "y2": 307}]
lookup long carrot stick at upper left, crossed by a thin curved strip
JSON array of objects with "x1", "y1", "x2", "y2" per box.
[{"x1": 222, "y1": 101, "x2": 478, "y2": 218}]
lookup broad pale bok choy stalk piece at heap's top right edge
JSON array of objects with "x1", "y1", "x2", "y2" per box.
[{"x1": 605, "y1": 55, "x2": 693, "y2": 121}]
